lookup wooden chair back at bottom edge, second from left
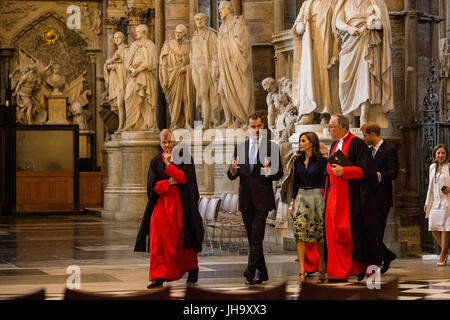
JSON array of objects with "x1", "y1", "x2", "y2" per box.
[{"x1": 64, "y1": 286, "x2": 170, "y2": 300}]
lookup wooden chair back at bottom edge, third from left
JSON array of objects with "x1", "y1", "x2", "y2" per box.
[{"x1": 185, "y1": 282, "x2": 286, "y2": 300}]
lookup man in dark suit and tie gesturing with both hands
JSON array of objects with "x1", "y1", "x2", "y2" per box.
[{"x1": 227, "y1": 114, "x2": 283, "y2": 284}]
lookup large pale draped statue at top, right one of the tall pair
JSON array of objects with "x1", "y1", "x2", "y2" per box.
[{"x1": 332, "y1": 0, "x2": 394, "y2": 125}]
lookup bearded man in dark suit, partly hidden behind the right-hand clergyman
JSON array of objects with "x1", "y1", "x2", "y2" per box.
[{"x1": 361, "y1": 122, "x2": 398, "y2": 274}]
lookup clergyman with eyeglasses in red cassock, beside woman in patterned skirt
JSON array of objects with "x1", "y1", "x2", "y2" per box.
[{"x1": 325, "y1": 115, "x2": 378, "y2": 283}]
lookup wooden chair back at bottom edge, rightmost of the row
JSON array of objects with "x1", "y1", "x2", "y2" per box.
[{"x1": 298, "y1": 278, "x2": 398, "y2": 300}]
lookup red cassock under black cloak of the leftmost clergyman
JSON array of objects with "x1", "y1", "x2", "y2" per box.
[{"x1": 149, "y1": 164, "x2": 198, "y2": 281}]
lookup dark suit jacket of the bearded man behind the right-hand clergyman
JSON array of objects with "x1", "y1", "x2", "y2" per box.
[{"x1": 370, "y1": 141, "x2": 398, "y2": 208}]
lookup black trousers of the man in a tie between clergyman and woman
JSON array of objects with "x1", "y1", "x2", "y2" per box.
[{"x1": 242, "y1": 204, "x2": 269, "y2": 280}]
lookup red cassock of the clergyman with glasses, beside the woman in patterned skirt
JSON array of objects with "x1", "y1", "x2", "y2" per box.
[{"x1": 325, "y1": 133, "x2": 367, "y2": 279}]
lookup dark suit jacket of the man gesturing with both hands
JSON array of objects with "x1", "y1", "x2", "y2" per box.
[{"x1": 227, "y1": 138, "x2": 283, "y2": 212}]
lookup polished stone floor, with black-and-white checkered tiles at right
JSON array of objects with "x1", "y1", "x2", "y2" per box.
[{"x1": 0, "y1": 215, "x2": 450, "y2": 300}]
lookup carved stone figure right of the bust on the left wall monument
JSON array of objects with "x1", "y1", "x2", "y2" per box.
[{"x1": 64, "y1": 71, "x2": 92, "y2": 130}]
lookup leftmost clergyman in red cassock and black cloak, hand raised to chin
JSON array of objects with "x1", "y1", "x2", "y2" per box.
[{"x1": 135, "y1": 129, "x2": 204, "y2": 289}]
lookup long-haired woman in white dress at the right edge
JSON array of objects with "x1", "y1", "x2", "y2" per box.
[{"x1": 424, "y1": 144, "x2": 450, "y2": 267}]
